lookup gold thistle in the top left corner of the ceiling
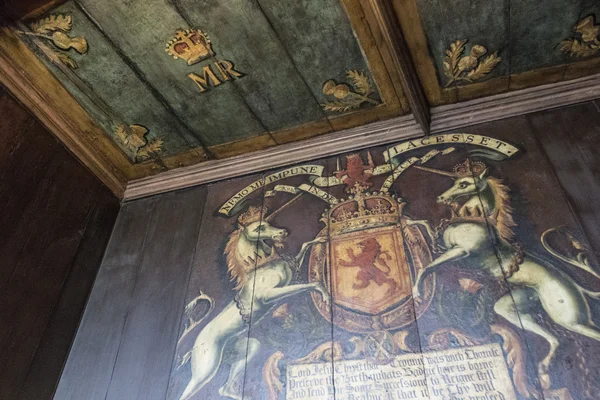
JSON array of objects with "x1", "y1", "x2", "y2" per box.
[{"x1": 18, "y1": 14, "x2": 88, "y2": 69}]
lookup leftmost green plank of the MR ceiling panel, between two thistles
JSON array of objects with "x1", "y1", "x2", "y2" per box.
[{"x1": 25, "y1": 3, "x2": 200, "y2": 161}]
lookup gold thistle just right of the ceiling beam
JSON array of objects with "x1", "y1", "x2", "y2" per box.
[{"x1": 444, "y1": 40, "x2": 502, "y2": 87}]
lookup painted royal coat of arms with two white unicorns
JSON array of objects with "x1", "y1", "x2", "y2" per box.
[{"x1": 167, "y1": 133, "x2": 600, "y2": 400}]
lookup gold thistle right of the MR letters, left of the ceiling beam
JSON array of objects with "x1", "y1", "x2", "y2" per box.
[{"x1": 321, "y1": 70, "x2": 379, "y2": 112}]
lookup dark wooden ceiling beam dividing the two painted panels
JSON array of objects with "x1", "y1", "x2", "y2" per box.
[{"x1": 369, "y1": 0, "x2": 431, "y2": 135}]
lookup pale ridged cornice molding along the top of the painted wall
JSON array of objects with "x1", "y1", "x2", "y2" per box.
[{"x1": 124, "y1": 74, "x2": 600, "y2": 200}]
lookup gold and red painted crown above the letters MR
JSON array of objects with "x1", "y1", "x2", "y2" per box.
[{"x1": 165, "y1": 29, "x2": 215, "y2": 65}]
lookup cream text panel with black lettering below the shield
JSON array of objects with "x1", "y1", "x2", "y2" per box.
[{"x1": 286, "y1": 343, "x2": 516, "y2": 400}]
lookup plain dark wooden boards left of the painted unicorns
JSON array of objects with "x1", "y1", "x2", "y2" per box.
[{"x1": 56, "y1": 187, "x2": 206, "y2": 400}]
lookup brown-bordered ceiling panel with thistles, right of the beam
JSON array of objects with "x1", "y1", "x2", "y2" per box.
[{"x1": 393, "y1": 0, "x2": 600, "y2": 106}]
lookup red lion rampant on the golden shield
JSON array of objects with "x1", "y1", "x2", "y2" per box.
[{"x1": 339, "y1": 238, "x2": 397, "y2": 294}]
